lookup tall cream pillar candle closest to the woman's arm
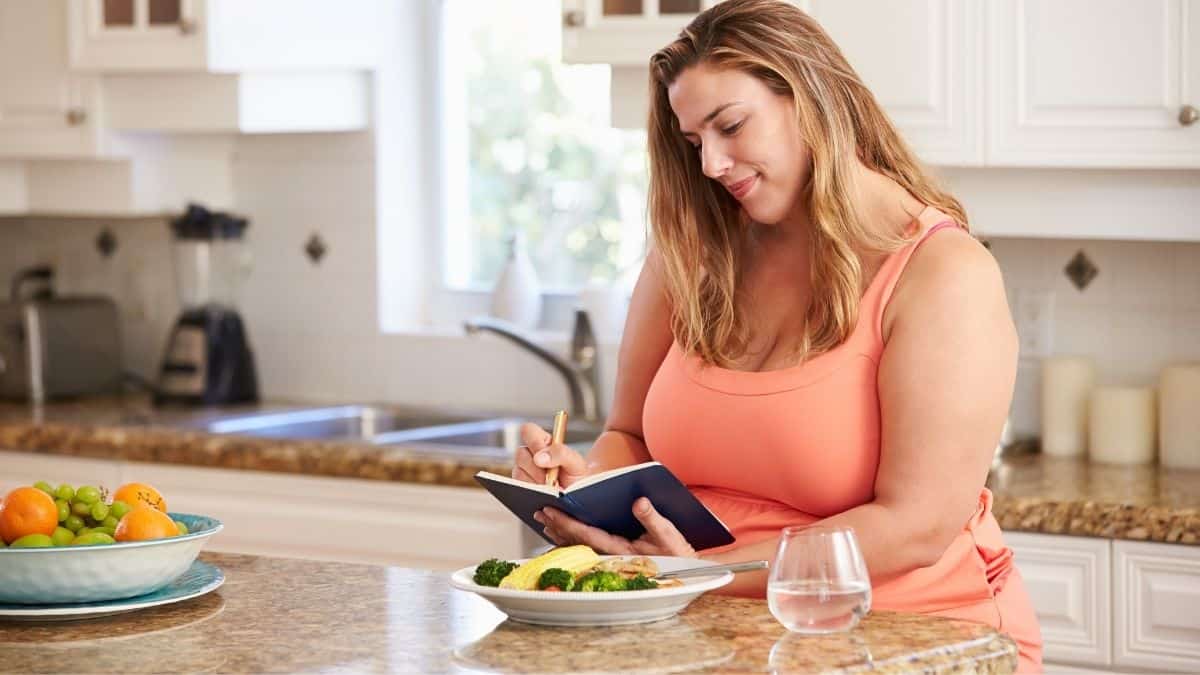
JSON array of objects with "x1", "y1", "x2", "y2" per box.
[{"x1": 1042, "y1": 357, "x2": 1096, "y2": 456}]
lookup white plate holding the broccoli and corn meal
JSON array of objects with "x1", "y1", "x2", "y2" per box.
[{"x1": 450, "y1": 556, "x2": 733, "y2": 626}]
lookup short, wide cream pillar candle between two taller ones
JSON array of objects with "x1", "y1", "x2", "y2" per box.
[{"x1": 1087, "y1": 387, "x2": 1158, "y2": 464}]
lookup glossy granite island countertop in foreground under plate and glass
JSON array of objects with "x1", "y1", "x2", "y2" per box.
[{"x1": 0, "y1": 552, "x2": 1016, "y2": 673}]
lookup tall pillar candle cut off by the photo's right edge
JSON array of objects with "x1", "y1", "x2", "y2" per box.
[{"x1": 1158, "y1": 363, "x2": 1200, "y2": 468}]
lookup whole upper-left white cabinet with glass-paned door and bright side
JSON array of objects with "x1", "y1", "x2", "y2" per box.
[{"x1": 67, "y1": 0, "x2": 383, "y2": 72}]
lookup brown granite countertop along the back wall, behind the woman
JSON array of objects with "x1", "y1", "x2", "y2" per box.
[{"x1": 0, "y1": 396, "x2": 1200, "y2": 545}]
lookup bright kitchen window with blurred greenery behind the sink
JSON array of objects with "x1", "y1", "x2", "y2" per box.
[{"x1": 434, "y1": 0, "x2": 647, "y2": 293}]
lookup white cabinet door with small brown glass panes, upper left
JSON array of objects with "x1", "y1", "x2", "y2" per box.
[{"x1": 67, "y1": 0, "x2": 208, "y2": 71}]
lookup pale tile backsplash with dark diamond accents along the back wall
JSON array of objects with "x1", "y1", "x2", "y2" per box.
[{"x1": 0, "y1": 211, "x2": 1200, "y2": 436}]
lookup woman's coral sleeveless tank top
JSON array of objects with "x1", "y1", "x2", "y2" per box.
[{"x1": 642, "y1": 211, "x2": 1013, "y2": 625}]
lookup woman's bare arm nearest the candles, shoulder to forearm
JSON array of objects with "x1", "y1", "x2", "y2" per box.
[{"x1": 706, "y1": 233, "x2": 1018, "y2": 595}]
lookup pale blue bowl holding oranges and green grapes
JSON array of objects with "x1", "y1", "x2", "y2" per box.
[{"x1": 0, "y1": 513, "x2": 222, "y2": 604}]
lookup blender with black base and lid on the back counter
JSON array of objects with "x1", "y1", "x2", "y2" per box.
[{"x1": 155, "y1": 204, "x2": 258, "y2": 405}]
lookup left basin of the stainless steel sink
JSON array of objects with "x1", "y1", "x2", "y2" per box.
[{"x1": 192, "y1": 406, "x2": 470, "y2": 441}]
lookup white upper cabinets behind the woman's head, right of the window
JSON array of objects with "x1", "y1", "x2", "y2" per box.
[{"x1": 563, "y1": 0, "x2": 1200, "y2": 168}]
